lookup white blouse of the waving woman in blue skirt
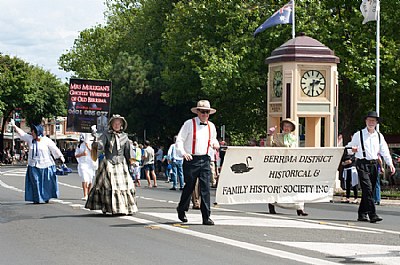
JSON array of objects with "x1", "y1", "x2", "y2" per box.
[{"x1": 20, "y1": 132, "x2": 62, "y2": 168}]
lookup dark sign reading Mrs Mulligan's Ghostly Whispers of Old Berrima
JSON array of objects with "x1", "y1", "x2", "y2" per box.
[{"x1": 67, "y1": 78, "x2": 111, "y2": 133}]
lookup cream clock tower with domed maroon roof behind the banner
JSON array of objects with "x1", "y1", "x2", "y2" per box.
[{"x1": 265, "y1": 34, "x2": 339, "y2": 147}]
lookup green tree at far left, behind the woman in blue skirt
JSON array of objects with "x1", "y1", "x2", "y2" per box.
[{"x1": 0, "y1": 54, "x2": 68, "y2": 157}]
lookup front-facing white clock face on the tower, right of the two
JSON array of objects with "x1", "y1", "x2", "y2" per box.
[{"x1": 300, "y1": 70, "x2": 325, "y2": 97}]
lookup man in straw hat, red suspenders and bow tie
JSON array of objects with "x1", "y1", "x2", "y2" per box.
[{"x1": 176, "y1": 100, "x2": 219, "y2": 225}]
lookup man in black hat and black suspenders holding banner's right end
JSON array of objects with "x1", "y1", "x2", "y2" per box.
[{"x1": 347, "y1": 111, "x2": 395, "y2": 223}]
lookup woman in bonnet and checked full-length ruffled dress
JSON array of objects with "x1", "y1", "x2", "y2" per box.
[{"x1": 85, "y1": 115, "x2": 138, "y2": 215}]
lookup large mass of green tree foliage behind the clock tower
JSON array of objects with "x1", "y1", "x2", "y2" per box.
[{"x1": 60, "y1": 0, "x2": 400, "y2": 144}]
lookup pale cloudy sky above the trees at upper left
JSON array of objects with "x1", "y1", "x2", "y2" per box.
[{"x1": 0, "y1": 0, "x2": 106, "y2": 81}]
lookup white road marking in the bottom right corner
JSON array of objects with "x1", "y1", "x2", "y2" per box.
[{"x1": 269, "y1": 241, "x2": 400, "y2": 265}]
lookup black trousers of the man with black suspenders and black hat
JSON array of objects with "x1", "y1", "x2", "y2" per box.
[{"x1": 357, "y1": 161, "x2": 378, "y2": 218}]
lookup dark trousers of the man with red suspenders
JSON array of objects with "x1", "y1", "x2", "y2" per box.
[{"x1": 178, "y1": 155, "x2": 211, "y2": 220}]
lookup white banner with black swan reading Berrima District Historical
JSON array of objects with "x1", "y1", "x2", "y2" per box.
[{"x1": 216, "y1": 146, "x2": 343, "y2": 204}]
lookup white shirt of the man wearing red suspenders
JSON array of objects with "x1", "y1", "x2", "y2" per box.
[{"x1": 176, "y1": 117, "x2": 218, "y2": 156}]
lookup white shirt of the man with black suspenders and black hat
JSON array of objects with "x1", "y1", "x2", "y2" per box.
[{"x1": 347, "y1": 128, "x2": 393, "y2": 166}]
